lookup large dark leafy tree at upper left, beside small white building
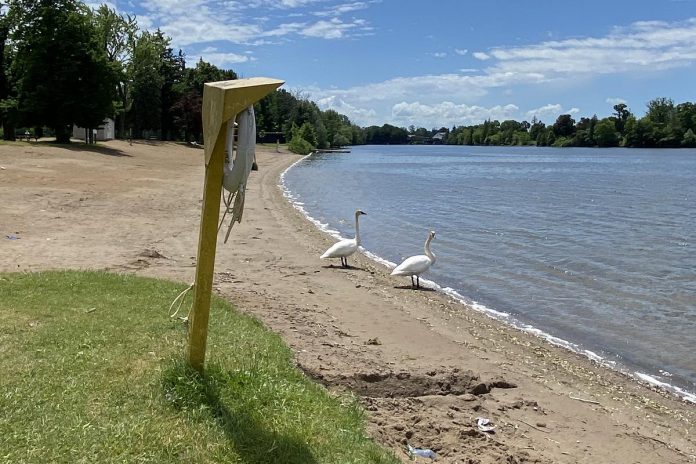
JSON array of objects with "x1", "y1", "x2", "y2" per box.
[{"x1": 10, "y1": 0, "x2": 116, "y2": 143}]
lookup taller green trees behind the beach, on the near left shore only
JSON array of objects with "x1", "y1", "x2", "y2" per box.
[{"x1": 0, "y1": 0, "x2": 365, "y2": 149}]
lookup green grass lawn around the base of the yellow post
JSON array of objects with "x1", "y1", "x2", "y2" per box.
[{"x1": 0, "y1": 271, "x2": 398, "y2": 463}]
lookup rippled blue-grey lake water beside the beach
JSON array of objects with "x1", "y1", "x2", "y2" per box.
[{"x1": 283, "y1": 146, "x2": 696, "y2": 402}]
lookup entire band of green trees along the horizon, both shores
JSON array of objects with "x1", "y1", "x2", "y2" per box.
[{"x1": 0, "y1": 0, "x2": 696, "y2": 153}]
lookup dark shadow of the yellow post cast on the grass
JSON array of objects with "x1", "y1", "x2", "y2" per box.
[{"x1": 162, "y1": 361, "x2": 317, "y2": 464}]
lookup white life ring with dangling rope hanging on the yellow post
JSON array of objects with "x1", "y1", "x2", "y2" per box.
[{"x1": 220, "y1": 105, "x2": 256, "y2": 242}]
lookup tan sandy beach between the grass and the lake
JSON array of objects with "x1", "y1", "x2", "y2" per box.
[{"x1": 0, "y1": 141, "x2": 696, "y2": 463}]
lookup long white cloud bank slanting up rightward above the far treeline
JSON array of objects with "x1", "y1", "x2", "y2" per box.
[{"x1": 312, "y1": 18, "x2": 696, "y2": 125}]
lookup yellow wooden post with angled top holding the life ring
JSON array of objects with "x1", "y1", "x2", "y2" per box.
[{"x1": 188, "y1": 77, "x2": 284, "y2": 372}]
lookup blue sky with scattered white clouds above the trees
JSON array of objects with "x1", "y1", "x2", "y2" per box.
[{"x1": 94, "y1": 0, "x2": 696, "y2": 128}]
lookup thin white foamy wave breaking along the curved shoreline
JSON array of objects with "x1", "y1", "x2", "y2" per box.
[{"x1": 279, "y1": 158, "x2": 696, "y2": 404}]
